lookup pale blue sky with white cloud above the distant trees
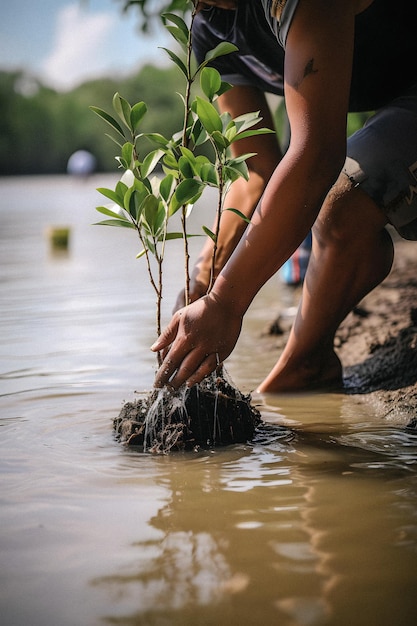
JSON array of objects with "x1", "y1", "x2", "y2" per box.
[{"x1": 0, "y1": 0, "x2": 173, "y2": 91}]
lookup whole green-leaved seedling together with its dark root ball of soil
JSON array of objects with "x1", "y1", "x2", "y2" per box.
[{"x1": 91, "y1": 0, "x2": 272, "y2": 451}]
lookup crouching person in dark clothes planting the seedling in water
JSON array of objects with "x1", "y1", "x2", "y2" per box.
[{"x1": 152, "y1": 0, "x2": 417, "y2": 392}]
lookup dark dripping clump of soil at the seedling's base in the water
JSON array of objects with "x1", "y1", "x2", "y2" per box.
[{"x1": 114, "y1": 374, "x2": 261, "y2": 452}]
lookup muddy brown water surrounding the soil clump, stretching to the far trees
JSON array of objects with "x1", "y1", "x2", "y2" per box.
[{"x1": 0, "y1": 177, "x2": 417, "y2": 626}]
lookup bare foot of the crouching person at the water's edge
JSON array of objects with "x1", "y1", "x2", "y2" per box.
[{"x1": 257, "y1": 350, "x2": 343, "y2": 393}]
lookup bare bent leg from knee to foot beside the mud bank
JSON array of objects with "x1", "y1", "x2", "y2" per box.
[{"x1": 258, "y1": 174, "x2": 394, "y2": 393}]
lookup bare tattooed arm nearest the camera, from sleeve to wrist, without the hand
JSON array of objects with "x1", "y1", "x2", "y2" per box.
[{"x1": 213, "y1": 0, "x2": 355, "y2": 315}]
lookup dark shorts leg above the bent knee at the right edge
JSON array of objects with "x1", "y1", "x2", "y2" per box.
[{"x1": 343, "y1": 85, "x2": 417, "y2": 241}]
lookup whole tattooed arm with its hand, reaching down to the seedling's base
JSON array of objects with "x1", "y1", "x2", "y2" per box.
[{"x1": 153, "y1": 0, "x2": 355, "y2": 387}]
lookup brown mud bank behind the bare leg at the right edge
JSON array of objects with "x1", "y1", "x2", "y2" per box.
[{"x1": 270, "y1": 236, "x2": 417, "y2": 426}]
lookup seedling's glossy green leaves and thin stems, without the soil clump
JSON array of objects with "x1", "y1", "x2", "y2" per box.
[{"x1": 91, "y1": 0, "x2": 273, "y2": 363}]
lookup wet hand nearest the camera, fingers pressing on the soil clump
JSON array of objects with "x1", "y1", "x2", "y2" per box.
[{"x1": 151, "y1": 294, "x2": 242, "y2": 389}]
